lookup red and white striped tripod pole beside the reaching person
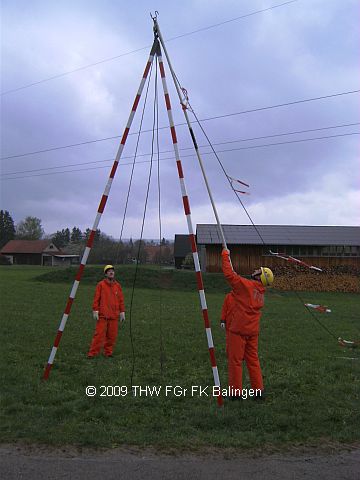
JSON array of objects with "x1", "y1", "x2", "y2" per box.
[{"x1": 156, "y1": 44, "x2": 223, "y2": 406}]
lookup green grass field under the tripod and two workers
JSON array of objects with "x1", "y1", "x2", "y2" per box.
[{"x1": 0, "y1": 266, "x2": 360, "y2": 450}]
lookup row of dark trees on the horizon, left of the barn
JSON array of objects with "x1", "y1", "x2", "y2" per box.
[{"x1": 0, "y1": 210, "x2": 173, "y2": 264}]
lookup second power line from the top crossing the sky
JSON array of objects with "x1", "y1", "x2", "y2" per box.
[{"x1": 0, "y1": 90, "x2": 360, "y2": 160}]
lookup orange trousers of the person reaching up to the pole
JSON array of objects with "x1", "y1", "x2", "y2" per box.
[{"x1": 226, "y1": 332, "x2": 264, "y2": 390}]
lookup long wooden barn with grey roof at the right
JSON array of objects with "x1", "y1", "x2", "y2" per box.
[{"x1": 196, "y1": 224, "x2": 360, "y2": 274}]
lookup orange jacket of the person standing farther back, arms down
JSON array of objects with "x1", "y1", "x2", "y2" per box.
[{"x1": 93, "y1": 279, "x2": 125, "y2": 319}]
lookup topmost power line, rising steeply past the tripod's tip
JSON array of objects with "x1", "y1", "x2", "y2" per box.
[{"x1": 1, "y1": 0, "x2": 299, "y2": 95}]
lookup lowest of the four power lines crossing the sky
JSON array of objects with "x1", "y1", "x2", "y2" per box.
[{"x1": 0, "y1": 132, "x2": 360, "y2": 180}]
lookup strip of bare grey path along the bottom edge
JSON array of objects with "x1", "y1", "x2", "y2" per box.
[{"x1": 0, "y1": 445, "x2": 360, "y2": 480}]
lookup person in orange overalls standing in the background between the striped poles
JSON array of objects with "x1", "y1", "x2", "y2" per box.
[{"x1": 88, "y1": 265, "x2": 125, "y2": 358}]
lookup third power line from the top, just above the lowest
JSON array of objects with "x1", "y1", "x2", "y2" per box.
[{"x1": 0, "y1": 122, "x2": 360, "y2": 177}]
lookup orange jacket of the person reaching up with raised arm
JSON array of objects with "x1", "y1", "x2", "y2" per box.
[{"x1": 221, "y1": 252, "x2": 265, "y2": 335}]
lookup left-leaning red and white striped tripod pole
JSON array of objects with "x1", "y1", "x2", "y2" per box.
[{"x1": 43, "y1": 41, "x2": 158, "y2": 380}]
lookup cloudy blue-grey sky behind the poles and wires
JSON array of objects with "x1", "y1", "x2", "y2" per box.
[{"x1": 0, "y1": 0, "x2": 360, "y2": 238}]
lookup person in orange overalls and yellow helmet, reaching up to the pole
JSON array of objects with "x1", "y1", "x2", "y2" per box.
[{"x1": 221, "y1": 248, "x2": 274, "y2": 399}]
